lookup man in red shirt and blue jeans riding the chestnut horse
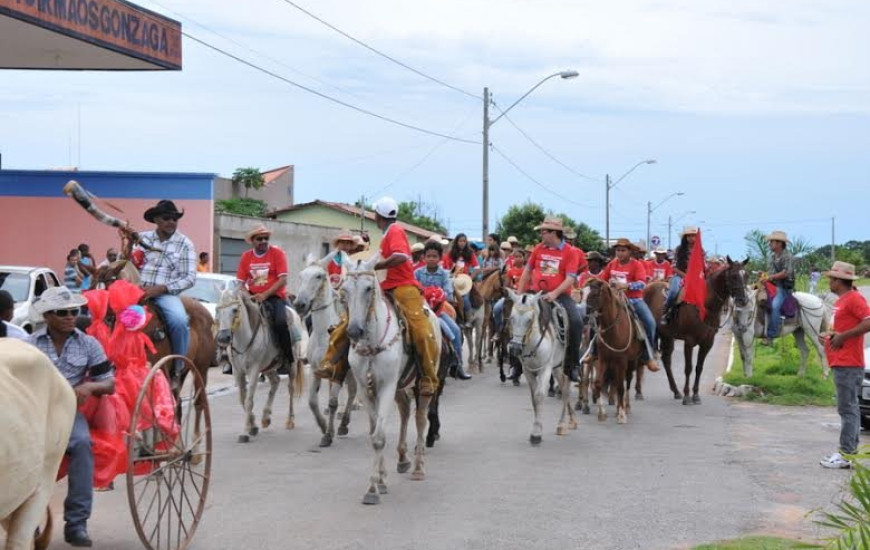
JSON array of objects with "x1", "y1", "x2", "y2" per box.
[{"x1": 600, "y1": 239, "x2": 659, "y2": 372}]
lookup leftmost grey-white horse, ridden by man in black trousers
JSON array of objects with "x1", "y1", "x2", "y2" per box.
[{"x1": 216, "y1": 288, "x2": 305, "y2": 443}]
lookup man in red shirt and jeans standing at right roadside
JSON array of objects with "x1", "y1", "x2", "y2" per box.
[{"x1": 819, "y1": 262, "x2": 870, "y2": 469}]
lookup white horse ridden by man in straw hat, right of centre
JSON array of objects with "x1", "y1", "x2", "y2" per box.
[{"x1": 508, "y1": 289, "x2": 577, "y2": 445}]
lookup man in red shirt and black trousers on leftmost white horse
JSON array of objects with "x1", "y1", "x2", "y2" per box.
[{"x1": 236, "y1": 224, "x2": 293, "y2": 374}]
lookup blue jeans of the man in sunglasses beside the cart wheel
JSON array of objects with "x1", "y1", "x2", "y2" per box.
[{"x1": 63, "y1": 412, "x2": 94, "y2": 531}]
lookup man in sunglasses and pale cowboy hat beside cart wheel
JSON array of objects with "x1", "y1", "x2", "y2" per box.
[{"x1": 28, "y1": 287, "x2": 115, "y2": 547}]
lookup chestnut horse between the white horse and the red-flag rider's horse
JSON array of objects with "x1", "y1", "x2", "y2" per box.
[{"x1": 586, "y1": 279, "x2": 656, "y2": 424}]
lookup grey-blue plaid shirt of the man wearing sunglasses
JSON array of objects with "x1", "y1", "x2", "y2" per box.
[{"x1": 27, "y1": 329, "x2": 115, "y2": 387}]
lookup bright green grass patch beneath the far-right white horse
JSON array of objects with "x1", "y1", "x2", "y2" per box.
[{"x1": 725, "y1": 336, "x2": 837, "y2": 407}]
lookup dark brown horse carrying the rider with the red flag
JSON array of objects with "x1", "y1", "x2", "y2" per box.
[{"x1": 658, "y1": 257, "x2": 749, "y2": 405}]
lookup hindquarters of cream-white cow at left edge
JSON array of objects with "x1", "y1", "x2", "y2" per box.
[{"x1": 0, "y1": 338, "x2": 76, "y2": 550}]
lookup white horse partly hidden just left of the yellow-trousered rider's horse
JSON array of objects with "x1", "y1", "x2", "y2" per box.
[{"x1": 293, "y1": 252, "x2": 356, "y2": 447}]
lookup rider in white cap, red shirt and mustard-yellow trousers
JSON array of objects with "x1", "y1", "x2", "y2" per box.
[{"x1": 314, "y1": 197, "x2": 440, "y2": 397}]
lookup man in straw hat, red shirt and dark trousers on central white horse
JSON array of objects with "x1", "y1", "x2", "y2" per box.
[{"x1": 517, "y1": 216, "x2": 585, "y2": 382}]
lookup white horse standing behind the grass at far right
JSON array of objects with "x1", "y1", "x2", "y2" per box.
[{"x1": 731, "y1": 289, "x2": 830, "y2": 377}]
